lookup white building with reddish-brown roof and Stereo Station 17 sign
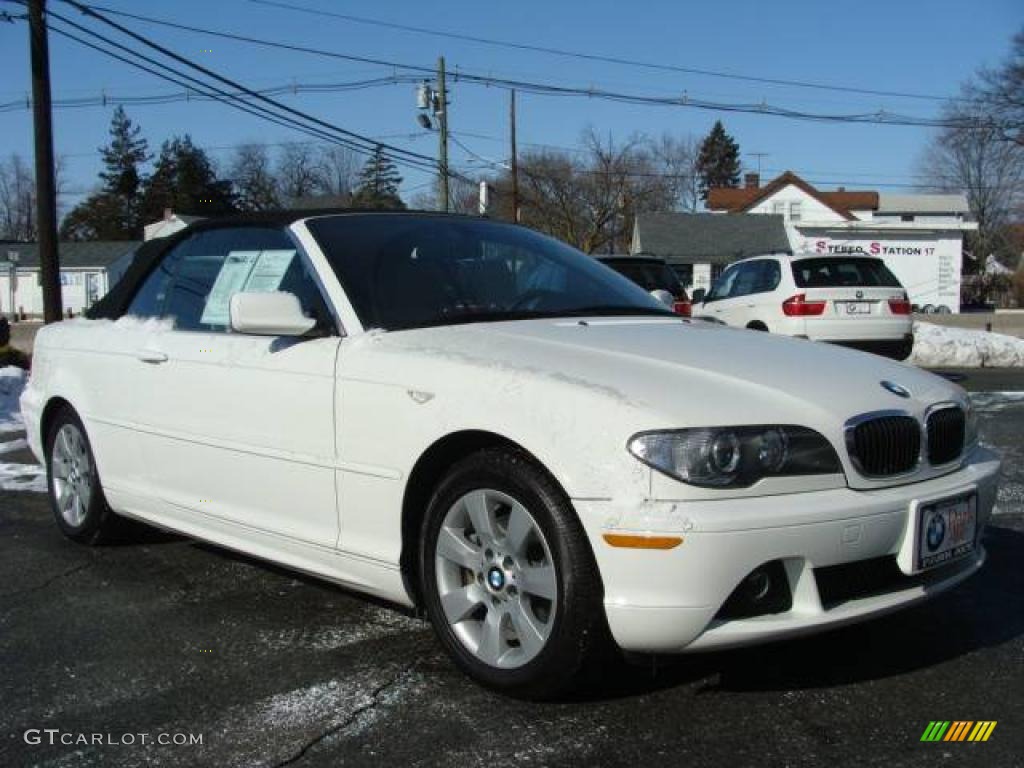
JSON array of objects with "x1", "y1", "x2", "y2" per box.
[{"x1": 708, "y1": 171, "x2": 978, "y2": 312}]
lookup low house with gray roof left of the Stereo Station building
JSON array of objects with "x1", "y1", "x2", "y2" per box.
[{"x1": 630, "y1": 213, "x2": 791, "y2": 291}]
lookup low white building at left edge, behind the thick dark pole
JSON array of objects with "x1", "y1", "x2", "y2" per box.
[{"x1": 0, "y1": 241, "x2": 139, "y2": 317}]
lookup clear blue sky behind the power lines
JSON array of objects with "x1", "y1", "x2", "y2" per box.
[{"x1": 0, "y1": 0, "x2": 1024, "y2": 214}]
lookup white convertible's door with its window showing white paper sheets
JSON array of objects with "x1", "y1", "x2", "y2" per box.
[{"x1": 125, "y1": 227, "x2": 340, "y2": 547}]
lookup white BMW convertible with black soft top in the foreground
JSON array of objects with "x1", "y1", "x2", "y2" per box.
[{"x1": 22, "y1": 213, "x2": 999, "y2": 696}]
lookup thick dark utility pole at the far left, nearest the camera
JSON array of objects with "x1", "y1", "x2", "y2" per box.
[{"x1": 29, "y1": 0, "x2": 63, "y2": 323}]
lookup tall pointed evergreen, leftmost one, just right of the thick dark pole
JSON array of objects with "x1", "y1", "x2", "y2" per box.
[{"x1": 60, "y1": 106, "x2": 150, "y2": 240}]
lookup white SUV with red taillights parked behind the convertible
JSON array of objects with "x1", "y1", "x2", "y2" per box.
[{"x1": 693, "y1": 253, "x2": 913, "y2": 359}]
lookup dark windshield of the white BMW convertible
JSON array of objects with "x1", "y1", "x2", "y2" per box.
[{"x1": 306, "y1": 213, "x2": 676, "y2": 331}]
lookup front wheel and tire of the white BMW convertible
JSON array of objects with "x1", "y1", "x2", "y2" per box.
[{"x1": 420, "y1": 450, "x2": 611, "y2": 699}]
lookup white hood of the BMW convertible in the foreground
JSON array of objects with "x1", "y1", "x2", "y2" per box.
[{"x1": 368, "y1": 317, "x2": 963, "y2": 427}]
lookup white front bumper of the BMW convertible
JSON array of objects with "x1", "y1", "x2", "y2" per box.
[{"x1": 574, "y1": 447, "x2": 999, "y2": 652}]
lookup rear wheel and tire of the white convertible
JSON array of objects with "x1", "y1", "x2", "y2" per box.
[{"x1": 46, "y1": 407, "x2": 118, "y2": 545}]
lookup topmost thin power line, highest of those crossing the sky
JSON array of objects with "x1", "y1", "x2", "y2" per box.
[{"x1": 249, "y1": 0, "x2": 951, "y2": 101}]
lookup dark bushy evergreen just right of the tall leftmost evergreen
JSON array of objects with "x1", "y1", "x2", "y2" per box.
[{"x1": 142, "y1": 134, "x2": 237, "y2": 221}]
